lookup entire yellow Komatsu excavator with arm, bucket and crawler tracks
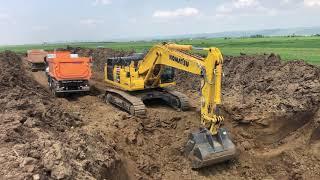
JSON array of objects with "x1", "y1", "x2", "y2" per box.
[{"x1": 105, "y1": 43, "x2": 236, "y2": 169}]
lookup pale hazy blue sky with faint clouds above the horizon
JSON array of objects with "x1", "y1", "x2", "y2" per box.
[{"x1": 0, "y1": 0, "x2": 320, "y2": 44}]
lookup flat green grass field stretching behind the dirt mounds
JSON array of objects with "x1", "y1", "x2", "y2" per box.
[{"x1": 0, "y1": 37, "x2": 320, "y2": 65}]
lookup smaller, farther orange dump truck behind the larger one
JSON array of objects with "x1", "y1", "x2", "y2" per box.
[{"x1": 27, "y1": 49, "x2": 48, "y2": 71}]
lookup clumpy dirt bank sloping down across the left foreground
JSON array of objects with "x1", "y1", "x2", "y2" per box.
[{"x1": 0, "y1": 52, "x2": 126, "y2": 179}]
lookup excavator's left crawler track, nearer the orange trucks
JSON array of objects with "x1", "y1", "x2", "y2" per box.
[{"x1": 105, "y1": 89, "x2": 146, "y2": 116}]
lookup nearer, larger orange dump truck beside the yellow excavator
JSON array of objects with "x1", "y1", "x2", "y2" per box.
[{"x1": 46, "y1": 51, "x2": 91, "y2": 96}]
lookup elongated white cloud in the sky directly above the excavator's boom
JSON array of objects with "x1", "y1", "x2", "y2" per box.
[{"x1": 153, "y1": 7, "x2": 199, "y2": 18}]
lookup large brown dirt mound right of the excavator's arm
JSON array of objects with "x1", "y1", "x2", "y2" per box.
[{"x1": 223, "y1": 54, "x2": 320, "y2": 142}]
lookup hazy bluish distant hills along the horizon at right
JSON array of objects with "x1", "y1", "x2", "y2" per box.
[{"x1": 152, "y1": 27, "x2": 320, "y2": 39}]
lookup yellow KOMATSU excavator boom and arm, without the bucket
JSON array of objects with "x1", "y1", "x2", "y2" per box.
[{"x1": 138, "y1": 44, "x2": 223, "y2": 134}]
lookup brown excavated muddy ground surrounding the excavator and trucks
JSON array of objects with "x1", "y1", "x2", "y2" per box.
[{"x1": 0, "y1": 48, "x2": 320, "y2": 179}]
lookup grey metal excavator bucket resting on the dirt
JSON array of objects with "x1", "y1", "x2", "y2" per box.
[{"x1": 185, "y1": 128, "x2": 236, "y2": 169}]
